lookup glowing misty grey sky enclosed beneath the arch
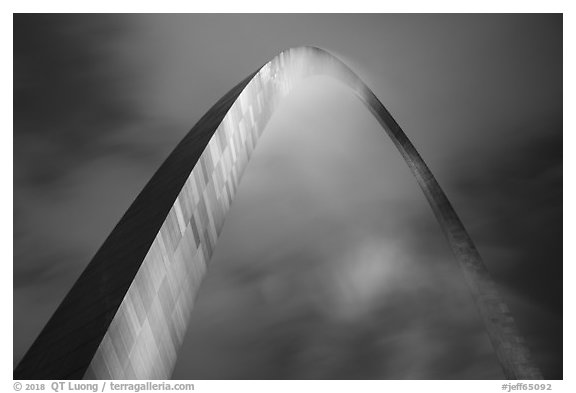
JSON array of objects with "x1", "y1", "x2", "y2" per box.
[{"x1": 174, "y1": 78, "x2": 501, "y2": 379}]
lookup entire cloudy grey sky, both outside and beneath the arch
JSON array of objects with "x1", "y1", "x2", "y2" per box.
[{"x1": 13, "y1": 14, "x2": 563, "y2": 379}]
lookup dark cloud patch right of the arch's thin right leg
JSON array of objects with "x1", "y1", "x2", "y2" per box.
[{"x1": 450, "y1": 125, "x2": 563, "y2": 379}]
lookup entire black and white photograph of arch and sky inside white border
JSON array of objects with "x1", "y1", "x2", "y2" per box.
[{"x1": 12, "y1": 8, "x2": 567, "y2": 382}]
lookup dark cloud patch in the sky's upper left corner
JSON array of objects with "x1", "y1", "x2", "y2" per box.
[{"x1": 14, "y1": 14, "x2": 167, "y2": 188}]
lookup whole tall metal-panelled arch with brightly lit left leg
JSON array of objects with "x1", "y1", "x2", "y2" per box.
[{"x1": 14, "y1": 47, "x2": 542, "y2": 379}]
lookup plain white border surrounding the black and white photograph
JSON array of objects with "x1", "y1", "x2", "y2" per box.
[{"x1": 0, "y1": 4, "x2": 576, "y2": 393}]
